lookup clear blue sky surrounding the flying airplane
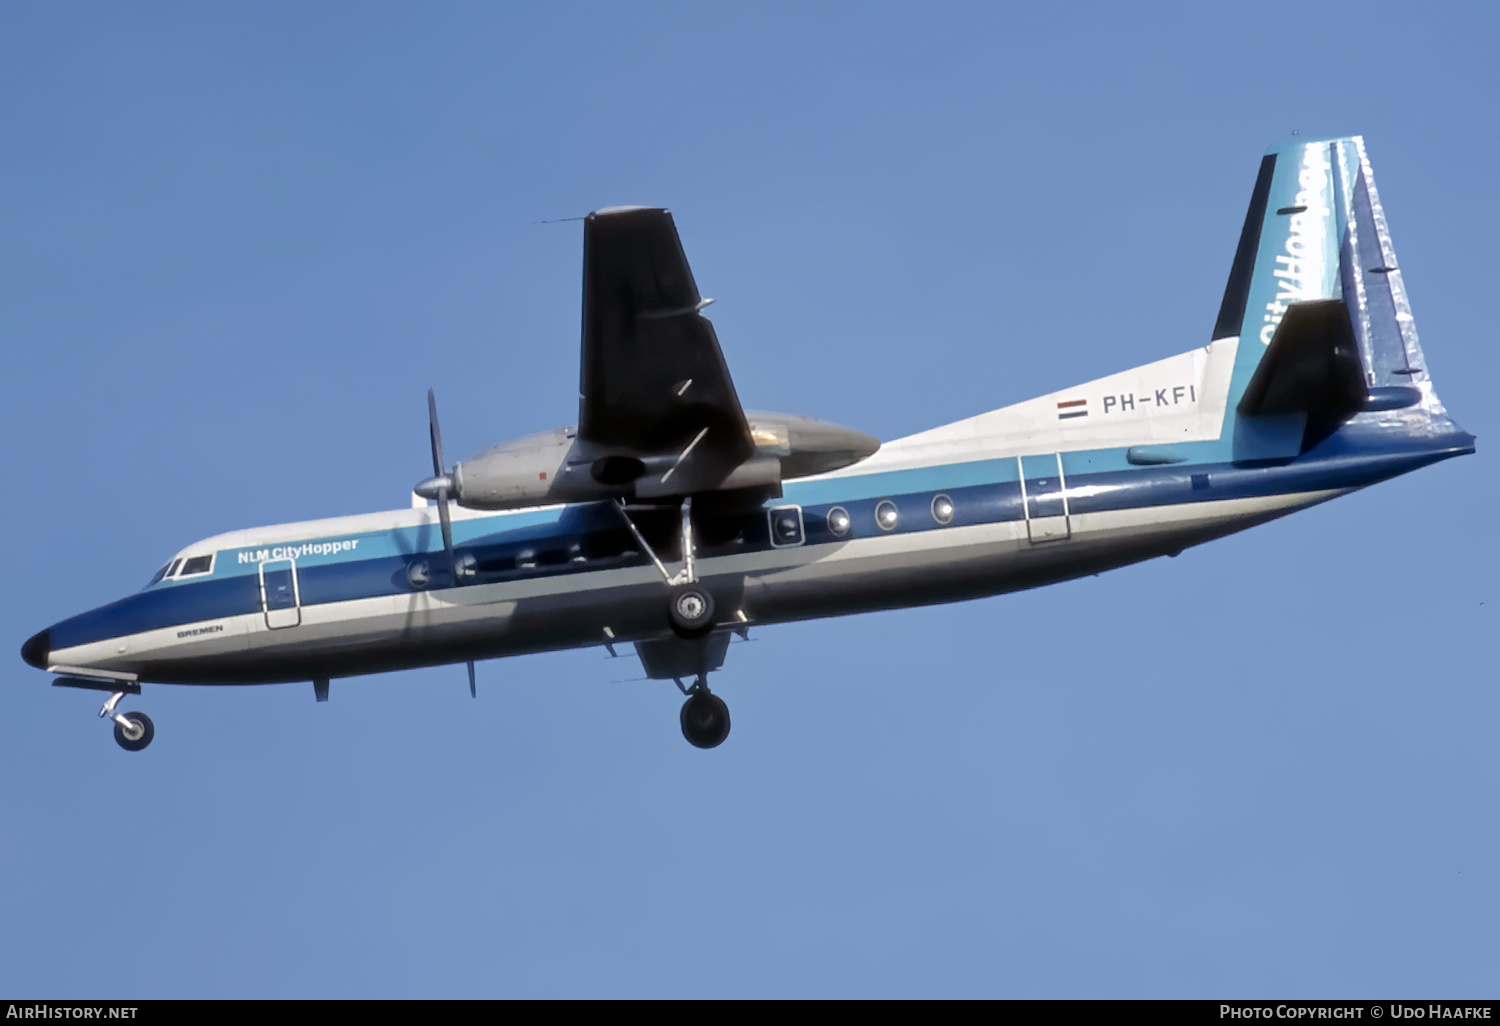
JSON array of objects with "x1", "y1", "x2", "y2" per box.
[{"x1": 0, "y1": 3, "x2": 1500, "y2": 998}]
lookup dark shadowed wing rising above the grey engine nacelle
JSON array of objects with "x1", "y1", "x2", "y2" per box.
[{"x1": 578, "y1": 207, "x2": 755, "y2": 491}]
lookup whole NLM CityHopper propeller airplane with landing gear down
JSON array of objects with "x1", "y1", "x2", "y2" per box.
[{"x1": 21, "y1": 137, "x2": 1475, "y2": 752}]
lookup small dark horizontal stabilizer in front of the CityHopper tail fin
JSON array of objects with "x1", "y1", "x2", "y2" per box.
[{"x1": 1239, "y1": 299, "x2": 1367, "y2": 422}]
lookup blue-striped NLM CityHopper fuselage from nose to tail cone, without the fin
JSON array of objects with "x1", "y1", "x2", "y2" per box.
[{"x1": 26, "y1": 354, "x2": 1473, "y2": 684}]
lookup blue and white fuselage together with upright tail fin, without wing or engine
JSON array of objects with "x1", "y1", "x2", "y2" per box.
[{"x1": 23, "y1": 138, "x2": 1475, "y2": 726}]
